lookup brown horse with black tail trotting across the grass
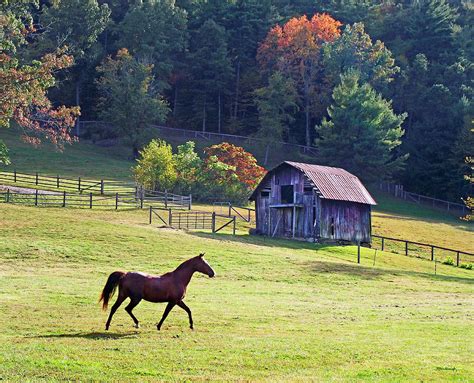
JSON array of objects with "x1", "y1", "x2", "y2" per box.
[{"x1": 99, "y1": 253, "x2": 215, "y2": 331}]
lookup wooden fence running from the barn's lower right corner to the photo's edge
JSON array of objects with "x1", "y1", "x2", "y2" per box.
[{"x1": 372, "y1": 235, "x2": 474, "y2": 266}]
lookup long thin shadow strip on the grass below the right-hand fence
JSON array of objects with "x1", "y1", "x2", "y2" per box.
[{"x1": 308, "y1": 261, "x2": 474, "y2": 284}]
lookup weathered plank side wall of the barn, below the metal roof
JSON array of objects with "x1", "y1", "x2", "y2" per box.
[{"x1": 319, "y1": 199, "x2": 371, "y2": 242}]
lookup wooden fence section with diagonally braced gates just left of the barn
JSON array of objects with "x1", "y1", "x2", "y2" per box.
[{"x1": 148, "y1": 206, "x2": 236, "y2": 235}]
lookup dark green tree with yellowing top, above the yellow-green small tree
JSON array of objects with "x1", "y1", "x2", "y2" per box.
[{"x1": 97, "y1": 49, "x2": 169, "y2": 157}]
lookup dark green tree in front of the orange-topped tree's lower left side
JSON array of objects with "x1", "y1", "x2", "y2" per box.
[{"x1": 255, "y1": 72, "x2": 298, "y2": 163}]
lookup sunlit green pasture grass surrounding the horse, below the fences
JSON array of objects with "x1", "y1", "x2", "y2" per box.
[{"x1": 0, "y1": 205, "x2": 474, "y2": 381}]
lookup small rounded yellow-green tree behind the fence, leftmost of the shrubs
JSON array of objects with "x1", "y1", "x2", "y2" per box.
[{"x1": 133, "y1": 140, "x2": 176, "y2": 190}]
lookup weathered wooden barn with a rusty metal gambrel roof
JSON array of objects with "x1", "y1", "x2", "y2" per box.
[{"x1": 250, "y1": 161, "x2": 376, "y2": 243}]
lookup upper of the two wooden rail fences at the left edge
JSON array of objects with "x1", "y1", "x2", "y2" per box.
[{"x1": 0, "y1": 170, "x2": 135, "y2": 194}]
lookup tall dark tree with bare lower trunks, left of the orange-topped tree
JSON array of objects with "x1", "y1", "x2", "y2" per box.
[{"x1": 189, "y1": 20, "x2": 232, "y2": 132}]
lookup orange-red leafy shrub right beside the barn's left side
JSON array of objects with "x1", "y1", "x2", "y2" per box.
[{"x1": 204, "y1": 142, "x2": 267, "y2": 189}]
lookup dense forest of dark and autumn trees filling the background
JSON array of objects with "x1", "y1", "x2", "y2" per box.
[{"x1": 0, "y1": 0, "x2": 474, "y2": 202}]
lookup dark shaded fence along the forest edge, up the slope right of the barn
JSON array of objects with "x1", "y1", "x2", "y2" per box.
[{"x1": 379, "y1": 182, "x2": 469, "y2": 215}]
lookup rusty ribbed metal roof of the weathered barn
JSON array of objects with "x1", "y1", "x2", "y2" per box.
[{"x1": 251, "y1": 161, "x2": 377, "y2": 205}]
